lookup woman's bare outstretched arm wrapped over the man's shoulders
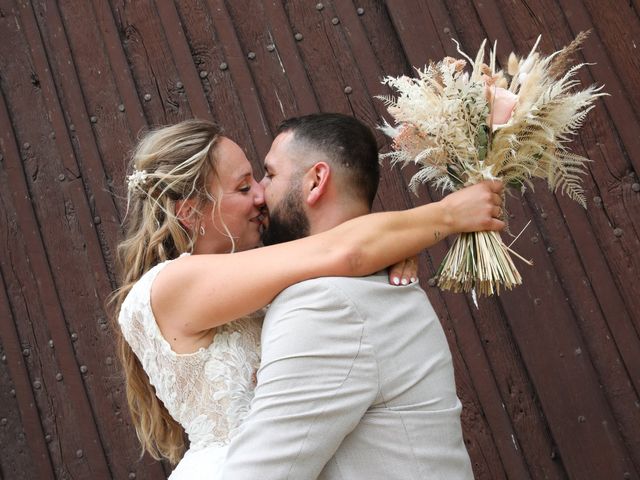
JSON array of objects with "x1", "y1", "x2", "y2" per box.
[{"x1": 152, "y1": 182, "x2": 504, "y2": 336}]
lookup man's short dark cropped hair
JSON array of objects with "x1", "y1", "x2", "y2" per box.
[{"x1": 276, "y1": 113, "x2": 380, "y2": 208}]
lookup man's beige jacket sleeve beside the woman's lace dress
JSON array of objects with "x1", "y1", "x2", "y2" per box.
[{"x1": 221, "y1": 278, "x2": 378, "y2": 480}]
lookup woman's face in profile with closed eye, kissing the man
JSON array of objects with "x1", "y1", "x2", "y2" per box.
[{"x1": 195, "y1": 137, "x2": 264, "y2": 253}]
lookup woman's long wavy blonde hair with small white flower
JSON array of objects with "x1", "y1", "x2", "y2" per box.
[{"x1": 111, "y1": 120, "x2": 221, "y2": 464}]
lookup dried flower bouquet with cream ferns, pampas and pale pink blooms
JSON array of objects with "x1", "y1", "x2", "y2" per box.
[{"x1": 379, "y1": 33, "x2": 606, "y2": 295}]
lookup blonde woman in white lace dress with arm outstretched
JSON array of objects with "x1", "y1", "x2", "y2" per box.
[{"x1": 114, "y1": 120, "x2": 502, "y2": 480}]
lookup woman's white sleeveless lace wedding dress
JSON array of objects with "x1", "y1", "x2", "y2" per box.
[{"x1": 118, "y1": 255, "x2": 264, "y2": 480}]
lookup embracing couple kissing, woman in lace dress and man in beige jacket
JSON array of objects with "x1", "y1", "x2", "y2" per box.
[{"x1": 115, "y1": 114, "x2": 504, "y2": 480}]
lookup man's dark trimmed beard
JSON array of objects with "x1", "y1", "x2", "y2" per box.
[{"x1": 262, "y1": 185, "x2": 309, "y2": 245}]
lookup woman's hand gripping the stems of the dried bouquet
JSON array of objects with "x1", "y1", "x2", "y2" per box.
[{"x1": 441, "y1": 180, "x2": 505, "y2": 232}]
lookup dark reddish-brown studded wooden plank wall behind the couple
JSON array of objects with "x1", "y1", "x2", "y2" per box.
[{"x1": 0, "y1": 0, "x2": 640, "y2": 480}]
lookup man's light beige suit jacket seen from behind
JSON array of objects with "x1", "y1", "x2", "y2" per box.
[{"x1": 222, "y1": 273, "x2": 473, "y2": 480}]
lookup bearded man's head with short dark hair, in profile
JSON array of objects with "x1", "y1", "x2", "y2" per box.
[{"x1": 262, "y1": 113, "x2": 380, "y2": 245}]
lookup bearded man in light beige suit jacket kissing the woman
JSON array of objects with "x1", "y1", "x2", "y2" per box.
[{"x1": 222, "y1": 114, "x2": 473, "y2": 480}]
